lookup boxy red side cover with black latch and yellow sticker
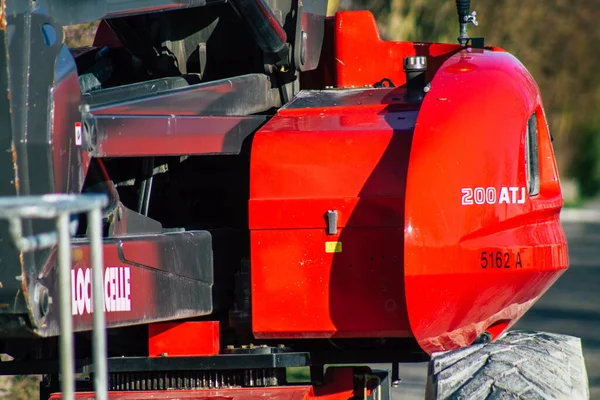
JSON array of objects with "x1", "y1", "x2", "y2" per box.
[{"x1": 250, "y1": 89, "x2": 417, "y2": 338}]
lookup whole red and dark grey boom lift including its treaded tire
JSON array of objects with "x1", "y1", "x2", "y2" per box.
[{"x1": 0, "y1": 0, "x2": 588, "y2": 400}]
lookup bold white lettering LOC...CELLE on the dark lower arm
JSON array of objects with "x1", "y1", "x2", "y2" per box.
[{"x1": 71, "y1": 267, "x2": 131, "y2": 315}]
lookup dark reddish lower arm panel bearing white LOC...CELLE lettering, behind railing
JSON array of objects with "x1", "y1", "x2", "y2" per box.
[{"x1": 36, "y1": 231, "x2": 213, "y2": 336}]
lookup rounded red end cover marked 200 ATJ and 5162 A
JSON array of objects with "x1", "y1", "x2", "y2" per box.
[{"x1": 404, "y1": 50, "x2": 568, "y2": 352}]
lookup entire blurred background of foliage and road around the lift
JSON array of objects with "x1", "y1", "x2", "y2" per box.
[{"x1": 0, "y1": 0, "x2": 600, "y2": 399}]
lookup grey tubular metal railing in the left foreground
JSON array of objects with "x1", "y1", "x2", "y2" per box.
[{"x1": 0, "y1": 194, "x2": 108, "y2": 400}]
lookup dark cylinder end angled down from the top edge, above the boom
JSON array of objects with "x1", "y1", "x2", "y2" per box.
[{"x1": 231, "y1": 0, "x2": 287, "y2": 54}]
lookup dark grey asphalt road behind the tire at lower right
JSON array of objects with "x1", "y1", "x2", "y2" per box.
[{"x1": 382, "y1": 221, "x2": 600, "y2": 400}]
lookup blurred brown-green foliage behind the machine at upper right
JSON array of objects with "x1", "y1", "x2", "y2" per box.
[{"x1": 329, "y1": 0, "x2": 600, "y2": 196}]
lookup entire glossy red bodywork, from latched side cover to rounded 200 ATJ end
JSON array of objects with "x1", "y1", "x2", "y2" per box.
[{"x1": 249, "y1": 13, "x2": 568, "y2": 353}]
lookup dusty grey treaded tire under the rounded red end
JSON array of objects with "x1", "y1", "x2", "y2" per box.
[{"x1": 425, "y1": 331, "x2": 589, "y2": 400}]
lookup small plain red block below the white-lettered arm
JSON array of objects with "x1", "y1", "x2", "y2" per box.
[{"x1": 148, "y1": 321, "x2": 220, "y2": 357}]
